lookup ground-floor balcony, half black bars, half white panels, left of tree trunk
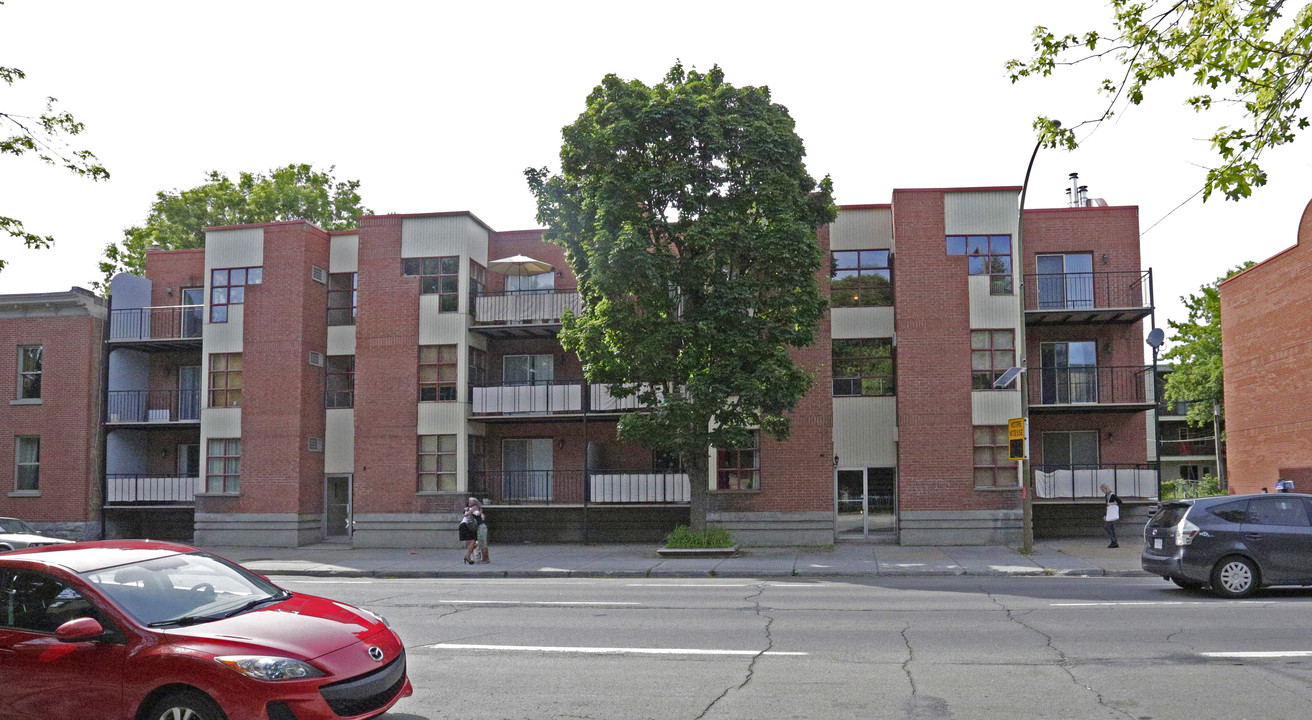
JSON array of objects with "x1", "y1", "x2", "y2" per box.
[{"x1": 470, "y1": 470, "x2": 691, "y2": 505}]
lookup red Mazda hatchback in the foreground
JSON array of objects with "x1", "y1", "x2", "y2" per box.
[{"x1": 0, "y1": 540, "x2": 412, "y2": 720}]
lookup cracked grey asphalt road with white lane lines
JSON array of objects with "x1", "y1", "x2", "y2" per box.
[{"x1": 273, "y1": 569, "x2": 1312, "y2": 720}]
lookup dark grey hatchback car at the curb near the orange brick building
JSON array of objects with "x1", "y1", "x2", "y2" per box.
[{"x1": 1140, "y1": 493, "x2": 1312, "y2": 598}]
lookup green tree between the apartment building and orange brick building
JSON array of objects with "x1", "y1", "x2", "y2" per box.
[{"x1": 1162, "y1": 262, "x2": 1253, "y2": 428}]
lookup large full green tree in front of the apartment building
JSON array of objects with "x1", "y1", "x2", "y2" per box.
[{"x1": 526, "y1": 64, "x2": 837, "y2": 530}]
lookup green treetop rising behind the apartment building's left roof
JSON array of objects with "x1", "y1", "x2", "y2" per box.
[{"x1": 97, "y1": 164, "x2": 370, "y2": 290}]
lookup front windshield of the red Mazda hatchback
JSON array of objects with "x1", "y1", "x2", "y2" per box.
[{"x1": 83, "y1": 552, "x2": 290, "y2": 627}]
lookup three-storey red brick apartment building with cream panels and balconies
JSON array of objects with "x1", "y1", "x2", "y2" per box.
[{"x1": 0, "y1": 178, "x2": 1157, "y2": 547}]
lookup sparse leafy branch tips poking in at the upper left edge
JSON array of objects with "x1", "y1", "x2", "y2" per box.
[{"x1": 0, "y1": 3, "x2": 109, "y2": 270}]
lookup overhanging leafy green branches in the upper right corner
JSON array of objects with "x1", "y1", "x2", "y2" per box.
[{"x1": 1006, "y1": 0, "x2": 1312, "y2": 201}]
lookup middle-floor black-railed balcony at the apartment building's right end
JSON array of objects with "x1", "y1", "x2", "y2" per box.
[{"x1": 1026, "y1": 366, "x2": 1153, "y2": 413}]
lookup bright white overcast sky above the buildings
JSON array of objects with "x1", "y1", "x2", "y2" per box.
[{"x1": 0, "y1": 0, "x2": 1312, "y2": 348}]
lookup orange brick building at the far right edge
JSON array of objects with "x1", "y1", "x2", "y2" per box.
[{"x1": 1220, "y1": 196, "x2": 1312, "y2": 493}]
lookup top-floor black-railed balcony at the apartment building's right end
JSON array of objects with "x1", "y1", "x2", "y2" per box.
[{"x1": 1025, "y1": 270, "x2": 1153, "y2": 325}]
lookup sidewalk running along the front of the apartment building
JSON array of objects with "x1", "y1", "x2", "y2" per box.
[{"x1": 206, "y1": 538, "x2": 1148, "y2": 578}]
